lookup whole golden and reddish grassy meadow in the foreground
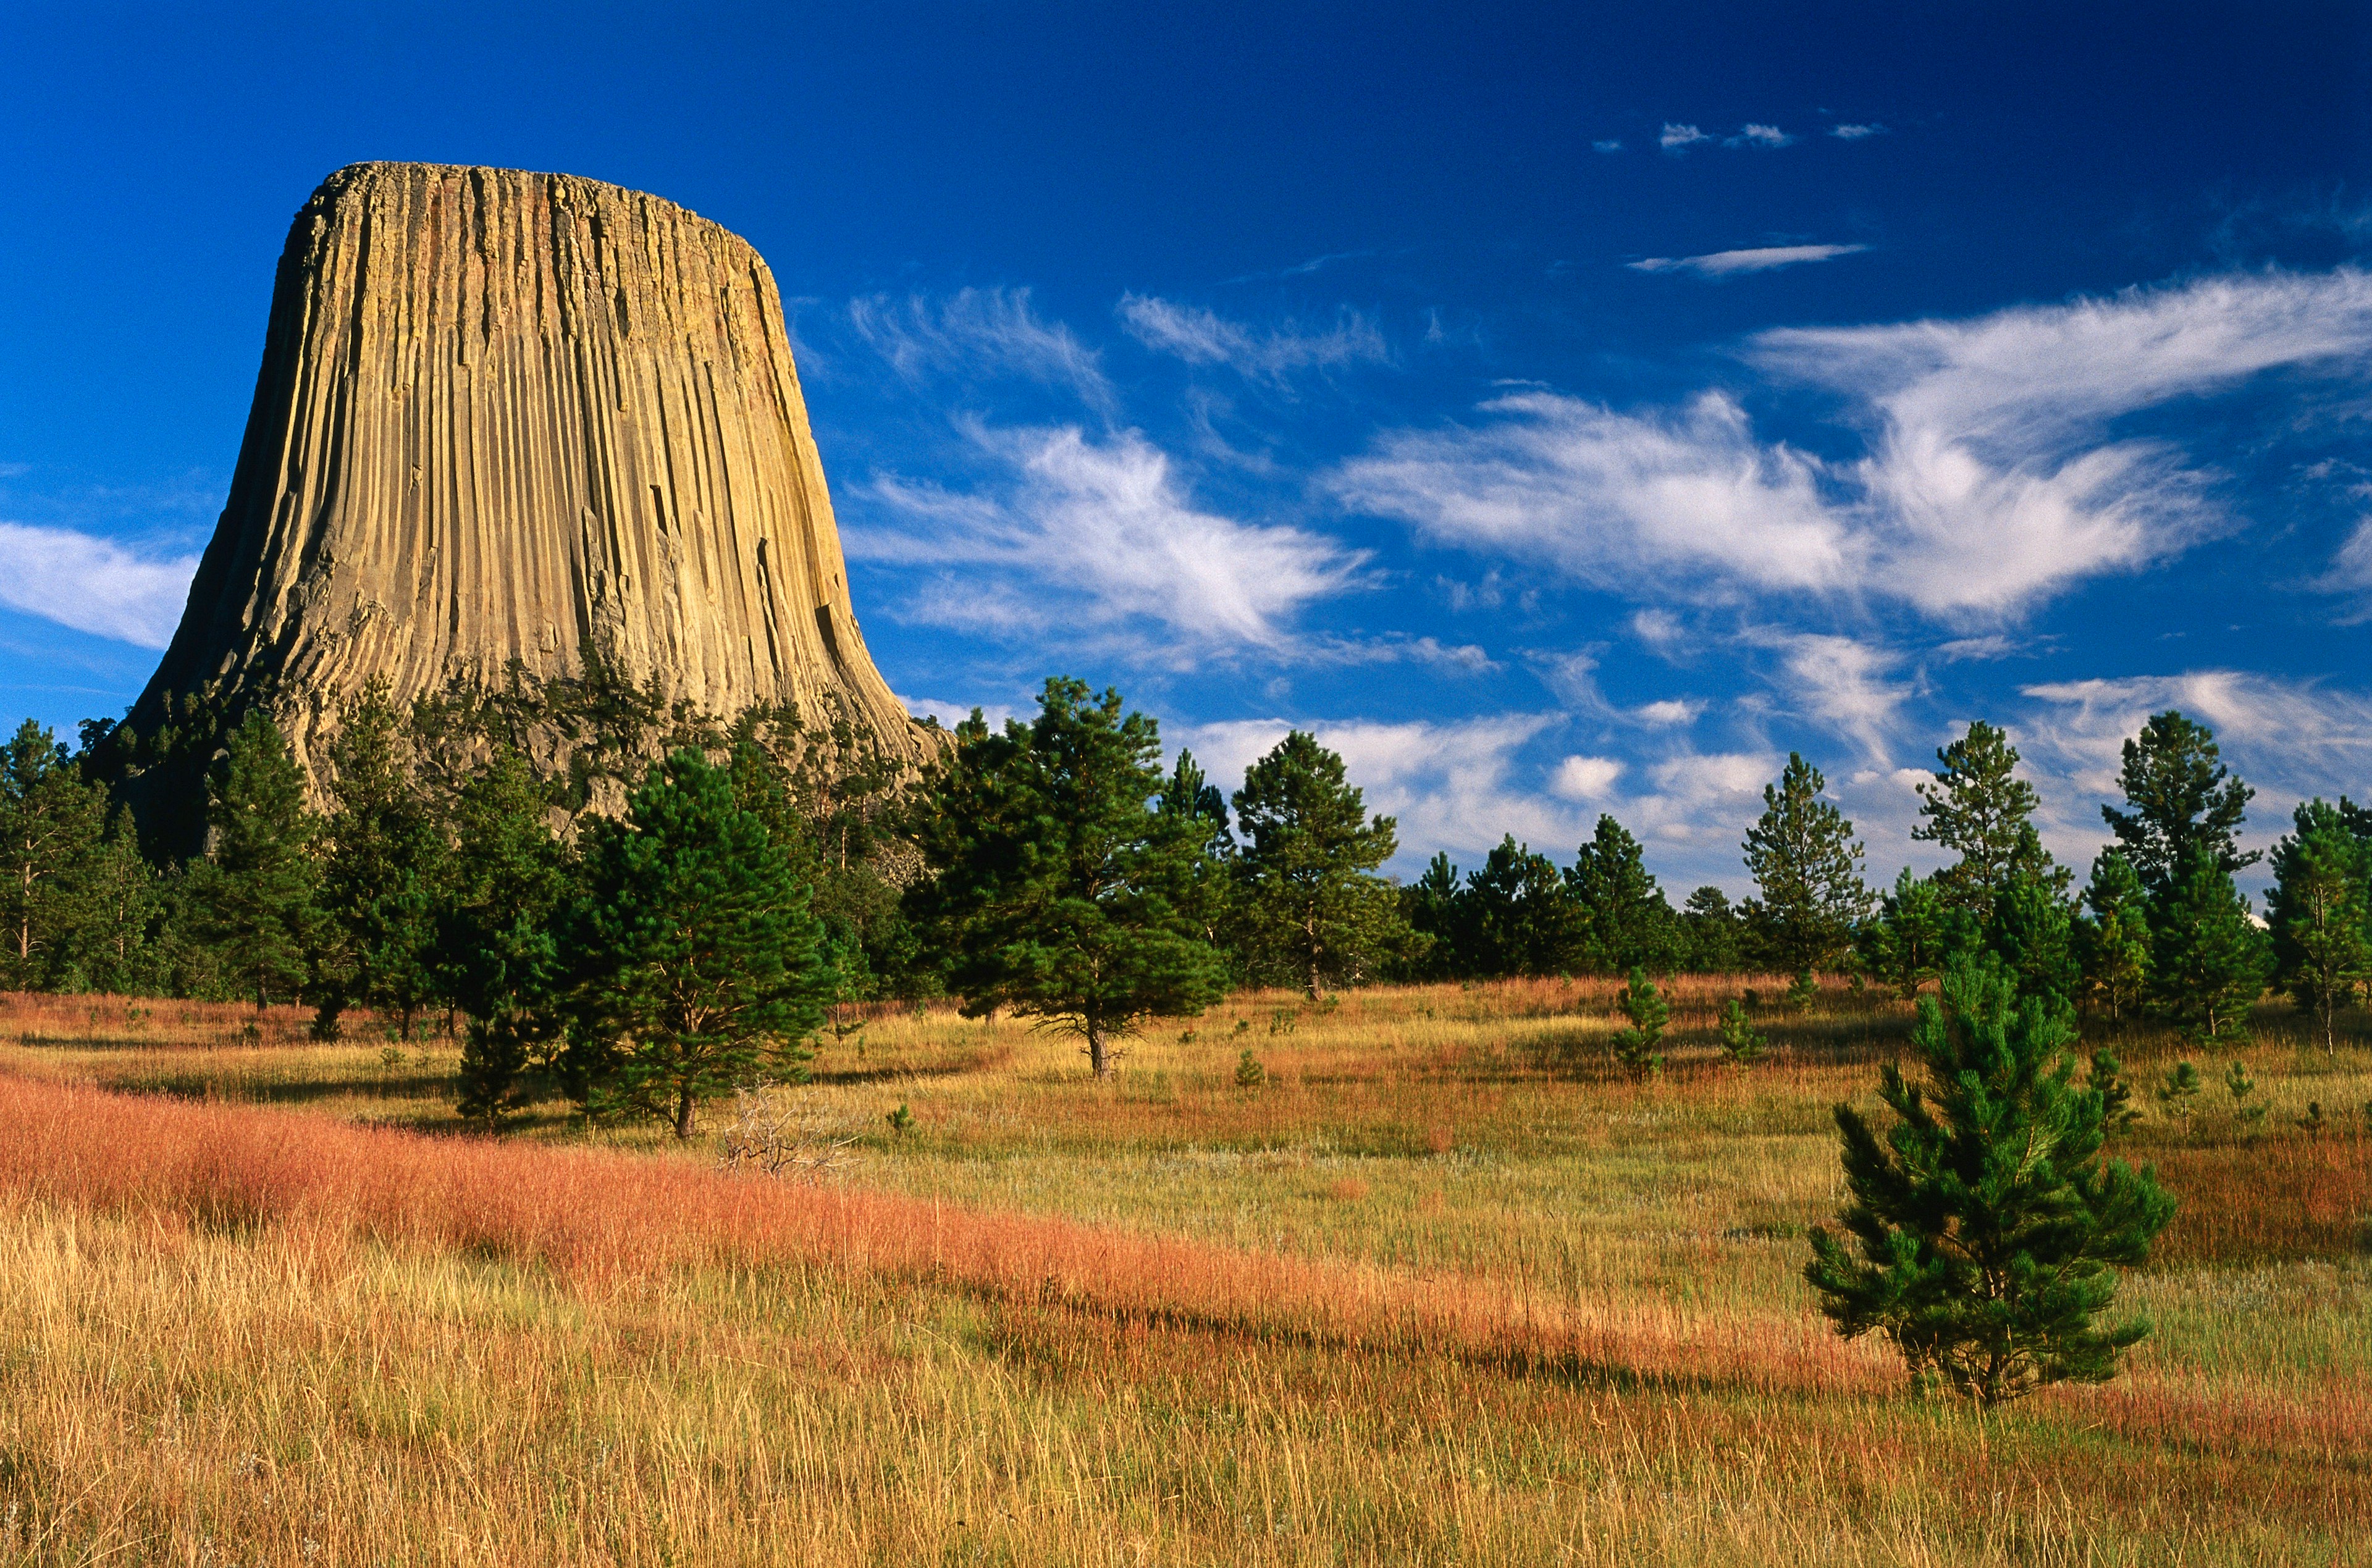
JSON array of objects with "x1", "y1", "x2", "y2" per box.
[{"x1": 0, "y1": 979, "x2": 2372, "y2": 1563}]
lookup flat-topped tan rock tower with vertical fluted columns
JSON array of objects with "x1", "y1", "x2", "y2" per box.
[{"x1": 126, "y1": 164, "x2": 935, "y2": 787}]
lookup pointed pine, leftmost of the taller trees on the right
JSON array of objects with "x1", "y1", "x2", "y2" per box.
[{"x1": 1746, "y1": 752, "x2": 1869, "y2": 973}]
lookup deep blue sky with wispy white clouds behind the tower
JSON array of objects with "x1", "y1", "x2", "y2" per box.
[{"x1": 0, "y1": 5, "x2": 2372, "y2": 897}]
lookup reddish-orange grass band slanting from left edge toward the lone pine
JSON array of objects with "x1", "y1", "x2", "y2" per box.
[{"x1": 0, "y1": 1077, "x2": 1888, "y2": 1388}]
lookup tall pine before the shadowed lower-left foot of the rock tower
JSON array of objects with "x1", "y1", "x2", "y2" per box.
[{"x1": 190, "y1": 710, "x2": 320, "y2": 1008}]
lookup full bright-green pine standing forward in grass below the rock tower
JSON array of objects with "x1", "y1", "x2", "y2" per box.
[{"x1": 570, "y1": 750, "x2": 833, "y2": 1139}]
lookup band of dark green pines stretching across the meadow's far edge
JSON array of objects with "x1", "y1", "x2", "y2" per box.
[{"x1": 0, "y1": 674, "x2": 2372, "y2": 1131}]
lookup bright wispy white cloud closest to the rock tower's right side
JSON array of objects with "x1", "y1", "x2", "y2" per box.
[{"x1": 847, "y1": 427, "x2": 1366, "y2": 652}]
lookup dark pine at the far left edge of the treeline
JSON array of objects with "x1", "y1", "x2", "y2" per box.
[{"x1": 0, "y1": 719, "x2": 107, "y2": 989}]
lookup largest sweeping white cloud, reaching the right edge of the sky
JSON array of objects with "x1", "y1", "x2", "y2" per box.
[{"x1": 1331, "y1": 268, "x2": 2372, "y2": 621}]
